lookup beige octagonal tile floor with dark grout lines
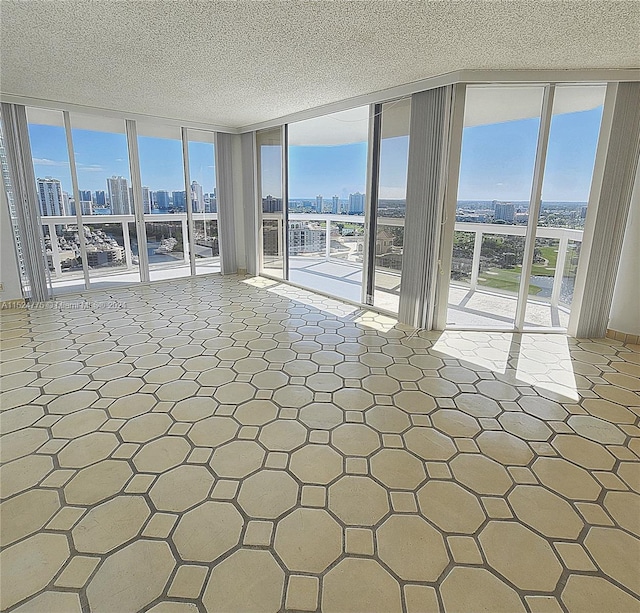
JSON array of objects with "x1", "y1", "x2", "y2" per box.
[{"x1": 0, "y1": 276, "x2": 640, "y2": 613}]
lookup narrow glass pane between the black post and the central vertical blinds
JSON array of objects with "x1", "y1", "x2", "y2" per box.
[{"x1": 373, "y1": 99, "x2": 411, "y2": 313}]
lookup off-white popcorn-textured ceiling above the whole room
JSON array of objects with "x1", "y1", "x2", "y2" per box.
[{"x1": 0, "y1": 0, "x2": 640, "y2": 127}]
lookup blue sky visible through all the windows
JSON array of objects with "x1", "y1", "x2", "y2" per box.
[{"x1": 29, "y1": 108, "x2": 602, "y2": 202}]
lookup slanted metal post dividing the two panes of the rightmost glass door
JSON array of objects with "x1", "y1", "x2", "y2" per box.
[{"x1": 514, "y1": 84, "x2": 555, "y2": 331}]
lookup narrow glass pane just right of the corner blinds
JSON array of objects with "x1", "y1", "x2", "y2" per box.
[{"x1": 256, "y1": 128, "x2": 285, "y2": 278}]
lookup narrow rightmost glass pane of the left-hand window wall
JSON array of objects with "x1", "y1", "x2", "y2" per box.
[{"x1": 189, "y1": 130, "x2": 220, "y2": 275}]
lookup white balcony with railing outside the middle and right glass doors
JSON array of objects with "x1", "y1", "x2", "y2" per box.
[{"x1": 263, "y1": 213, "x2": 582, "y2": 329}]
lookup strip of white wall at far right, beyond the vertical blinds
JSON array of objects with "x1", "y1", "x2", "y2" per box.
[{"x1": 609, "y1": 158, "x2": 640, "y2": 334}]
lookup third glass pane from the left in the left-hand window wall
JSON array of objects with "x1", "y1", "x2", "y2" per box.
[{"x1": 138, "y1": 133, "x2": 191, "y2": 281}]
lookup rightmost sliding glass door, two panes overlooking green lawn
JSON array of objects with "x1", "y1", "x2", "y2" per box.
[{"x1": 447, "y1": 85, "x2": 605, "y2": 330}]
